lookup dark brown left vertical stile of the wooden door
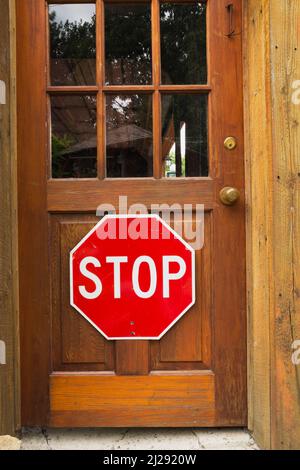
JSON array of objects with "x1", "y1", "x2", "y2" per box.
[{"x1": 16, "y1": 0, "x2": 50, "y2": 425}]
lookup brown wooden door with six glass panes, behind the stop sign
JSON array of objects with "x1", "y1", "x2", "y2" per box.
[{"x1": 17, "y1": 0, "x2": 247, "y2": 426}]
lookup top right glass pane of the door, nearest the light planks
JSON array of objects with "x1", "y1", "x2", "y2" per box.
[{"x1": 160, "y1": 3, "x2": 207, "y2": 85}]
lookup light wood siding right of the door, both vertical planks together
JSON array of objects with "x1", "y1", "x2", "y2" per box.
[{"x1": 245, "y1": 0, "x2": 300, "y2": 449}]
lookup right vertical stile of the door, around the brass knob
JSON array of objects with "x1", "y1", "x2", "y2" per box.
[{"x1": 209, "y1": 0, "x2": 247, "y2": 425}]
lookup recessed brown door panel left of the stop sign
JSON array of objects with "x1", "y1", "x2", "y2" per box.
[{"x1": 50, "y1": 214, "x2": 115, "y2": 371}]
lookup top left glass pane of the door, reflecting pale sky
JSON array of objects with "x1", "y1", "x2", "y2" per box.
[{"x1": 49, "y1": 3, "x2": 96, "y2": 86}]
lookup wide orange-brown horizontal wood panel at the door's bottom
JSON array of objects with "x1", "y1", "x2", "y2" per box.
[{"x1": 50, "y1": 372, "x2": 215, "y2": 427}]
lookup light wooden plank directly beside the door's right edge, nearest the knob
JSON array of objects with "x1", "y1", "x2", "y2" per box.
[{"x1": 244, "y1": 0, "x2": 273, "y2": 449}]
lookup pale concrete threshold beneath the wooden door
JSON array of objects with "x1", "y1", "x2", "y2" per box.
[{"x1": 21, "y1": 428, "x2": 258, "y2": 450}]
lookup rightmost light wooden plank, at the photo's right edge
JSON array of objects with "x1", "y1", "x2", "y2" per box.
[{"x1": 270, "y1": 0, "x2": 300, "y2": 449}]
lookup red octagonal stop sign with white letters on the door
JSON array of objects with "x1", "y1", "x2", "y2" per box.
[{"x1": 70, "y1": 215, "x2": 195, "y2": 340}]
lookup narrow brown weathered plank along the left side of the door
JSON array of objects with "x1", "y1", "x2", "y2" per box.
[{"x1": 0, "y1": 0, "x2": 20, "y2": 435}]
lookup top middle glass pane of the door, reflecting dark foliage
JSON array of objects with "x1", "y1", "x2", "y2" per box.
[{"x1": 105, "y1": 2, "x2": 152, "y2": 85}]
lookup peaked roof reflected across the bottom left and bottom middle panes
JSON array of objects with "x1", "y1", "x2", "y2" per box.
[{"x1": 63, "y1": 124, "x2": 152, "y2": 155}]
